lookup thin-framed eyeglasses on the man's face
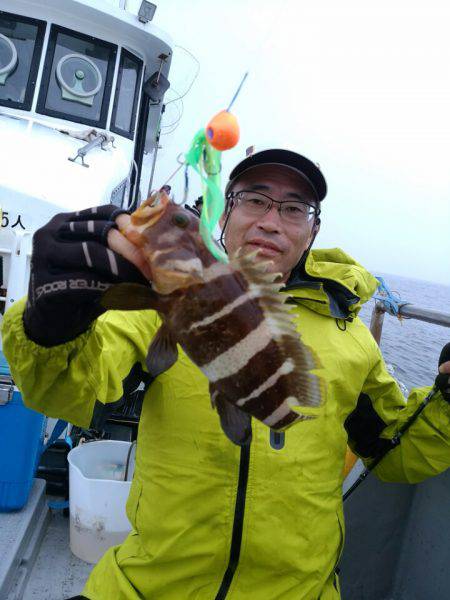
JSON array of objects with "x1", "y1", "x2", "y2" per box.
[{"x1": 227, "y1": 190, "x2": 320, "y2": 225}]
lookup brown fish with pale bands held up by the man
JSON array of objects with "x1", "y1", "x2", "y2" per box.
[{"x1": 103, "y1": 192, "x2": 321, "y2": 444}]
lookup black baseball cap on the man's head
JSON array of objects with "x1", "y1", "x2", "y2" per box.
[{"x1": 225, "y1": 149, "x2": 327, "y2": 202}]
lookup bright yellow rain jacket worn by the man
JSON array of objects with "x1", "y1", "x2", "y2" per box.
[{"x1": 3, "y1": 249, "x2": 450, "y2": 600}]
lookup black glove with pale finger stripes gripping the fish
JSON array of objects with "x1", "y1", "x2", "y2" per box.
[{"x1": 23, "y1": 204, "x2": 149, "y2": 347}]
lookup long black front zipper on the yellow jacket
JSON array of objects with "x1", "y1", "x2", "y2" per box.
[{"x1": 215, "y1": 444, "x2": 250, "y2": 600}]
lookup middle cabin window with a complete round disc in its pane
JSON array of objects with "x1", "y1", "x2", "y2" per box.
[{"x1": 37, "y1": 25, "x2": 117, "y2": 127}]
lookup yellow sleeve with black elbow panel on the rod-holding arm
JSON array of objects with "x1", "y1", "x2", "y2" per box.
[{"x1": 345, "y1": 348, "x2": 450, "y2": 483}]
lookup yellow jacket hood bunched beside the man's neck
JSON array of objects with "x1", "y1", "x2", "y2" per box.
[{"x1": 284, "y1": 248, "x2": 378, "y2": 319}]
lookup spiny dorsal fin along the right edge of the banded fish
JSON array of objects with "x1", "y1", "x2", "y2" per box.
[{"x1": 232, "y1": 247, "x2": 325, "y2": 407}]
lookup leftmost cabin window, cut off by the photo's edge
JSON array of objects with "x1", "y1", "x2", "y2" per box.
[{"x1": 0, "y1": 10, "x2": 45, "y2": 110}]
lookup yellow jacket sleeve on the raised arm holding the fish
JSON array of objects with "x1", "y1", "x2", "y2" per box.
[{"x1": 2, "y1": 299, "x2": 160, "y2": 428}]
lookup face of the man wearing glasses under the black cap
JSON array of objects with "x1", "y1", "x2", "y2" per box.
[{"x1": 221, "y1": 165, "x2": 316, "y2": 281}]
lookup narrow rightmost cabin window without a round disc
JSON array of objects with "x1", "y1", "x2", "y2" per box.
[{"x1": 111, "y1": 48, "x2": 142, "y2": 139}]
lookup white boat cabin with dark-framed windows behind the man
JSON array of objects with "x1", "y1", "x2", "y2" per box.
[{"x1": 0, "y1": 0, "x2": 172, "y2": 312}]
